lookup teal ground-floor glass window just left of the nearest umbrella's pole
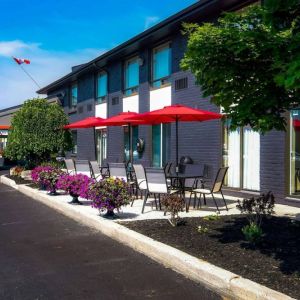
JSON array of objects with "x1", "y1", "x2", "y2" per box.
[{"x1": 152, "y1": 124, "x2": 171, "y2": 167}]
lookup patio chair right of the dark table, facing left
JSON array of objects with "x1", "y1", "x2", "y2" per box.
[{"x1": 190, "y1": 167, "x2": 228, "y2": 212}]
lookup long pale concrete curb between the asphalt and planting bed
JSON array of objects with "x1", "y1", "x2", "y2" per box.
[{"x1": 0, "y1": 176, "x2": 293, "y2": 300}]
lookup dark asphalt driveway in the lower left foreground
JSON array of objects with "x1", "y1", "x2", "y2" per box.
[{"x1": 0, "y1": 184, "x2": 220, "y2": 300}]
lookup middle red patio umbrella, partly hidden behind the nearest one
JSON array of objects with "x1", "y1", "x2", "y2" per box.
[{"x1": 92, "y1": 111, "x2": 149, "y2": 162}]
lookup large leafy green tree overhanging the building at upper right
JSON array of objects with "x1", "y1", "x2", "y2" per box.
[{"x1": 181, "y1": 0, "x2": 300, "y2": 133}]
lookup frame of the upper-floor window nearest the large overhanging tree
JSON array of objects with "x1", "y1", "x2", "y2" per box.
[{"x1": 151, "y1": 41, "x2": 172, "y2": 89}]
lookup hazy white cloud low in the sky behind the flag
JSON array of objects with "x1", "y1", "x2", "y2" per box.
[{"x1": 0, "y1": 40, "x2": 105, "y2": 109}]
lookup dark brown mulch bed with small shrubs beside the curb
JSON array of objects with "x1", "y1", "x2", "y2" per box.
[{"x1": 122, "y1": 215, "x2": 300, "y2": 299}]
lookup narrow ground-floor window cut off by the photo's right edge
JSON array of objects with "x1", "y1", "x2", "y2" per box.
[{"x1": 290, "y1": 109, "x2": 300, "y2": 195}]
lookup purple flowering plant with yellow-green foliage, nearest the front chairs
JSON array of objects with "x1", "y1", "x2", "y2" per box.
[{"x1": 89, "y1": 178, "x2": 131, "y2": 215}]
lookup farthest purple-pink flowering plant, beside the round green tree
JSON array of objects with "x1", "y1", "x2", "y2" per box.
[{"x1": 31, "y1": 166, "x2": 64, "y2": 194}]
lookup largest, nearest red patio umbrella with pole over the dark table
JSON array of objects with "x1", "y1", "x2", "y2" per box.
[{"x1": 125, "y1": 104, "x2": 222, "y2": 172}]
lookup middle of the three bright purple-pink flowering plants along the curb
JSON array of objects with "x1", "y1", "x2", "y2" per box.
[{"x1": 56, "y1": 174, "x2": 95, "y2": 199}]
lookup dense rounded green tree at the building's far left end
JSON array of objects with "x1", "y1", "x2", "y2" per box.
[{"x1": 5, "y1": 99, "x2": 72, "y2": 166}]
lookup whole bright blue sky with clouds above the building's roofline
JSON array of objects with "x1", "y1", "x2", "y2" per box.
[{"x1": 0, "y1": 0, "x2": 197, "y2": 109}]
